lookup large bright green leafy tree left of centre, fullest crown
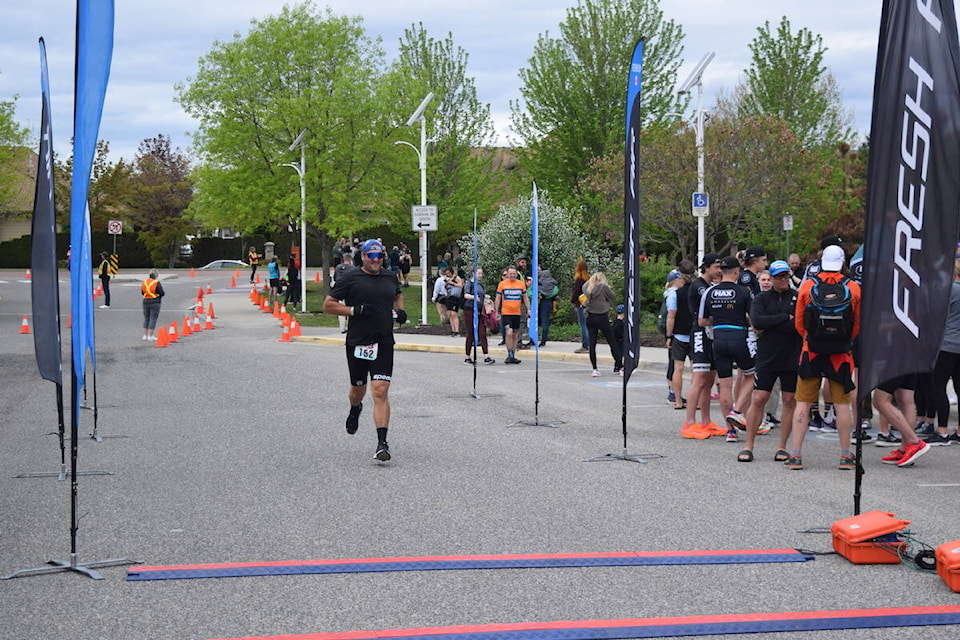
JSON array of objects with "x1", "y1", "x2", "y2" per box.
[{"x1": 177, "y1": 2, "x2": 404, "y2": 288}]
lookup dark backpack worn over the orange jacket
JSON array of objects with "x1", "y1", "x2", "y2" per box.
[{"x1": 803, "y1": 276, "x2": 854, "y2": 354}]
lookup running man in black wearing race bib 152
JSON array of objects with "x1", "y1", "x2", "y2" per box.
[{"x1": 323, "y1": 240, "x2": 407, "y2": 462}]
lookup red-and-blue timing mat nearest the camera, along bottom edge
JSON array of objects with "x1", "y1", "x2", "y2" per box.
[{"x1": 206, "y1": 605, "x2": 960, "y2": 640}]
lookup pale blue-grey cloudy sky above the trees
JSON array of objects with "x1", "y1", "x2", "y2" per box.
[{"x1": 0, "y1": 0, "x2": 881, "y2": 161}]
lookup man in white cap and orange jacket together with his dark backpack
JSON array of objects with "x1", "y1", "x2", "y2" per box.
[{"x1": 786, "y1": 245, "x2": 860, "y2": 470}]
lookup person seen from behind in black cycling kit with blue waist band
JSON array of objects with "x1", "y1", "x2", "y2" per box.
[{"x1": 698, "y1": 256, "x2": 755, "y2": 442}]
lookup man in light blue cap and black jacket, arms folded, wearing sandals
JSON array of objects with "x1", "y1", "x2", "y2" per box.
[{"x1": 737, "y1": 260, "x2": 803, "y2": 462}]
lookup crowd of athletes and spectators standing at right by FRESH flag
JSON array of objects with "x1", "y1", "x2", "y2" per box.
[{"x1": 664, "y1": 236, "x2": 960, "y2": 470}]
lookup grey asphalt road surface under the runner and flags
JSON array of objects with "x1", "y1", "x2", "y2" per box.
[{"x1": 0, "y1": 272, "x2": 960, "y2": 640}]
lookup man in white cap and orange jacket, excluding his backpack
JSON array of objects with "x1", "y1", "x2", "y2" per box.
[{"x1": 787, "y1": 244, "x2": 860, "y2": 470}]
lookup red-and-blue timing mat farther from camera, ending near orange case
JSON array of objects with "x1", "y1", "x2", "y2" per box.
[{"x1": 127, "y1": 549, "x2": 814, "y2": 580}]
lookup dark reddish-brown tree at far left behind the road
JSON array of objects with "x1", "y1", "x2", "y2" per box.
[{"x1": 128, "y1": 134, "x2": 195, "y2": 268}]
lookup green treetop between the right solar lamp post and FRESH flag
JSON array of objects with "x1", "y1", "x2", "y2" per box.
[{"x1": 736, "y1": 16, "x2": 853, "y2": 148}]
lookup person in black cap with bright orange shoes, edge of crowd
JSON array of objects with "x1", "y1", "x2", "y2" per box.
[{"x1": 680, "y1": 253, "x2": 727, "y2": 440}]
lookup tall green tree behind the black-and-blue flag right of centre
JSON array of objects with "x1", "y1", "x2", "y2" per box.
[{"x1": 511, "y1": 0, "x2": 686, "y2": 218}]
